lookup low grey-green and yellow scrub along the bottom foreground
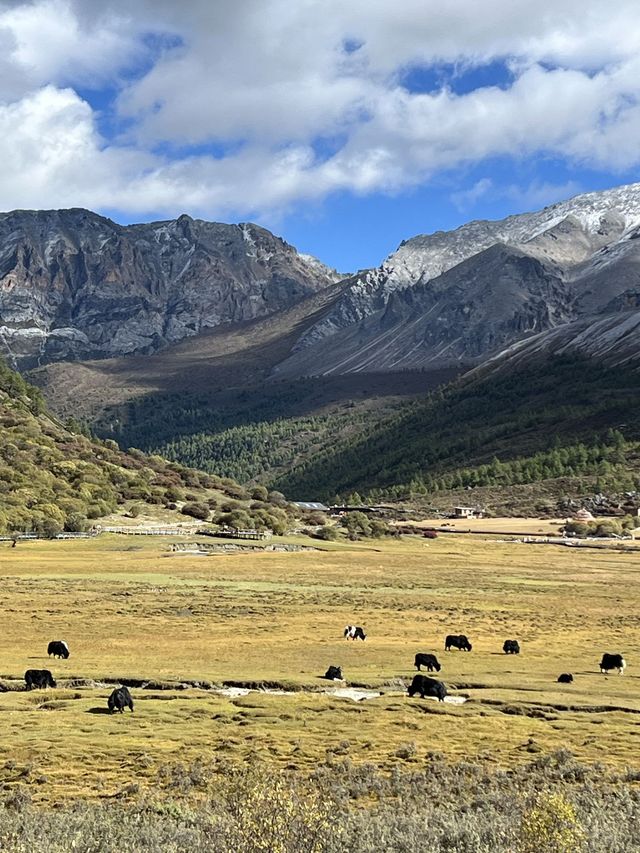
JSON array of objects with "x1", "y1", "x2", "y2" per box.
[{"x1": 0, "y1": 745, "x2": 640, "y2": 853}]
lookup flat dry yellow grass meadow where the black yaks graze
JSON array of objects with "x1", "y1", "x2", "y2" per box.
[{"x1": 0, "y1": 536, "x2": 640, "y2": 800}]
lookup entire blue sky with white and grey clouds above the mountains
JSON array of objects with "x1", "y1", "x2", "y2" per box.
[{"x1": 0, "y1": 0, "x2": 640, "y2": 271}]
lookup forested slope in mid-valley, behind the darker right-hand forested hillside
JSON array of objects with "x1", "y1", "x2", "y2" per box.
[{"x1": 85, "y1": 371, "x2": 440, "y2": 485}]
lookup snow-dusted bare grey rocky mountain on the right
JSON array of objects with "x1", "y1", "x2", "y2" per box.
[{"x1": 278, "y1": 184, "x2": 640, "y2": 376}]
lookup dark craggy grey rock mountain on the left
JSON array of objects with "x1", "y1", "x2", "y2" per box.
[{"x1": 0, "y1": 209, "x2": 340, "y2": 369}]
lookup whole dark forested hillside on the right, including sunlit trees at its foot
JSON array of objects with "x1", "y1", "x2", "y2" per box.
[{"x1": 277, "y1": 357, "x2": 640, "y2": 498}]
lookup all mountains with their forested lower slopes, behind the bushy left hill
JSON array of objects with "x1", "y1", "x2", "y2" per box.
[{"x1": 6, "y1": 184, "x2": 640, "y2": 510}]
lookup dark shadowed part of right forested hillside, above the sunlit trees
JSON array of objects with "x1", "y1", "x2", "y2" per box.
[{"x1": 276, "y1": 353, "x2": 640, "y2": 500}]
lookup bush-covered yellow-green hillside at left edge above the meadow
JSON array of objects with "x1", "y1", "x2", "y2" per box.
[{"x1": 0, "y1": 364, "x2": 249, "y2": 535}]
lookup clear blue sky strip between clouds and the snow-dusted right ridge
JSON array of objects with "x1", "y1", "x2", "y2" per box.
[{"x1": 282, "y1": 158, "x2": 640, "y2": 271}]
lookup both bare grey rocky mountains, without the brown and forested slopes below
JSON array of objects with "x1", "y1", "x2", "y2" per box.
[{"x1": 5, "y1": 184, "x2": 640, "y2": 377}]
